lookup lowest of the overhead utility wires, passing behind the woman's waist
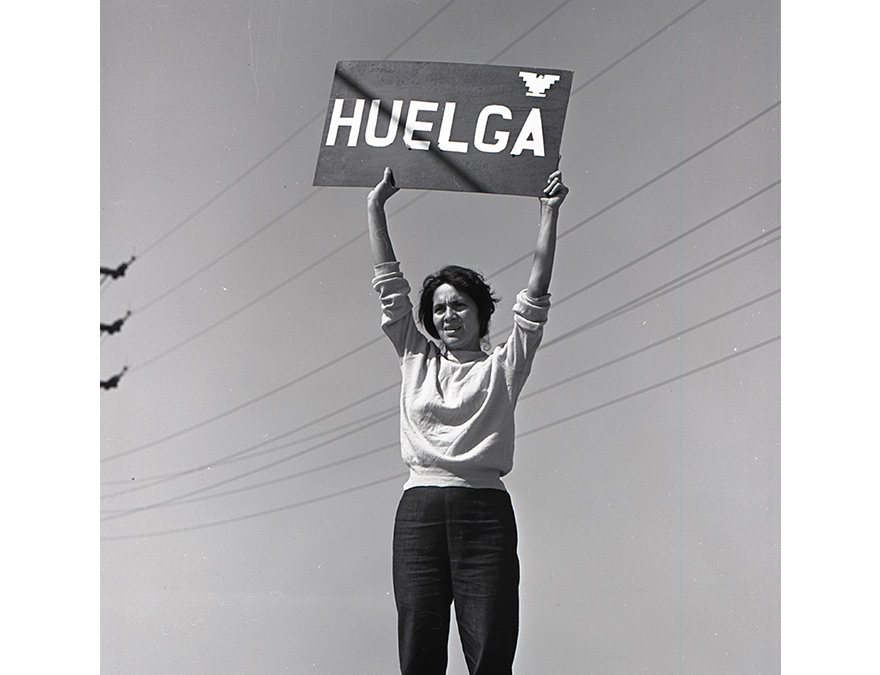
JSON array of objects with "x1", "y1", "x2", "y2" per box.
[{"x1": 101, "y1": 336, "x2": 781, "y2": 541}]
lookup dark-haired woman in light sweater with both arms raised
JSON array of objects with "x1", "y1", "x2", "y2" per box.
[{"x1": 367, "y1": 169, "x2": 568, "y2": 675}]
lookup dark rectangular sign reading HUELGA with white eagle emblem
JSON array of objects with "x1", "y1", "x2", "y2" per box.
[{"x1": 314, "y1": 61, "x2": 572, "y2": 196}]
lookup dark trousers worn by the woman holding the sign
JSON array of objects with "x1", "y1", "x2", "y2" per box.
[{"x1": 393, "y1": 487, "x2": 519, "y2": 675}]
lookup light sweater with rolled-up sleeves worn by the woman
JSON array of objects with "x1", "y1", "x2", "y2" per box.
[{"x1": 373, "y1": 262, "x2": 550, "y2": 490}]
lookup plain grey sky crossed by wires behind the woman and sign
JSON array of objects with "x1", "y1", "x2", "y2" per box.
[{"x1": 100, "y1": 0, "x2": 781, "y2": 675}]
